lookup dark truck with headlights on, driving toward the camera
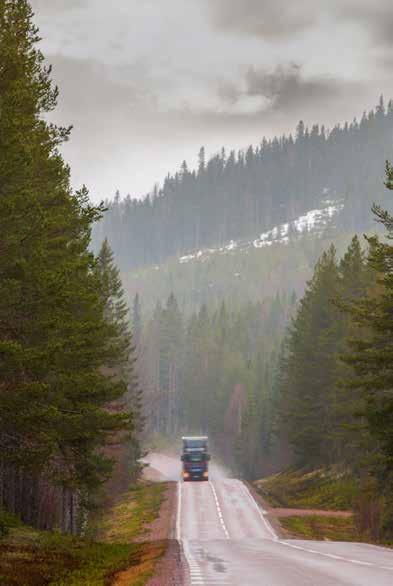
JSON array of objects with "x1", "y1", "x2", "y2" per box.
[{"x1": 181, "y1": 436, "x2": 210, "y2": 482}]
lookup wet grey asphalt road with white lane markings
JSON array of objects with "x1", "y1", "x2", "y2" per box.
[{"x1": 148, "y1": 454, "x2": 393, "y2": 586}]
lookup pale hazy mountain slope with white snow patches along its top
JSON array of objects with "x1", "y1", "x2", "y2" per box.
[{"x1": 123, "y1": 202, "x2": 352, "y2": 313}]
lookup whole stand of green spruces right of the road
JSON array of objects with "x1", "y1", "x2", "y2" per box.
[{"x1": 275, "y1": 165, "x2": 393, "y2": 538}]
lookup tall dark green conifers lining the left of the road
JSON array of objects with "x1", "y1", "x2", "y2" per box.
[{"x1": 0, "y1": 0, "x2": 141, "y2": 532}]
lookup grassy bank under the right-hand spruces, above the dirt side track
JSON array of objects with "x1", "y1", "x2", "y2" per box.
[{"x1": 255, "y1": 469, "x2": 358, "y2": 511}]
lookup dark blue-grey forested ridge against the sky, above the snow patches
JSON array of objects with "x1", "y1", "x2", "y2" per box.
[{"x1": 94, "y1": 98, "x2": 393, "y2": 270}]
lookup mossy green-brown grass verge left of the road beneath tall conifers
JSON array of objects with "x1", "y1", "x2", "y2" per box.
[{"x1": 0, "y1": 484, "x2": 166, "y2": 586}]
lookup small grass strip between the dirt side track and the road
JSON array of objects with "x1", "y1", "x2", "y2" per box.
[{"x1": 280, "y1": 515, "x2": 360, "y2": 541}]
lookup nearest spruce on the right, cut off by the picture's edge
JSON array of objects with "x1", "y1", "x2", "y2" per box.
[{"x1": 344, "y1": 164, "x2": 393, "y2": 535}]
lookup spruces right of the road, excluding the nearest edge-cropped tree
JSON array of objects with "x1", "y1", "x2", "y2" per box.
[{"x1": 276, "y1": 237, "x2": 372, "y2": 467}]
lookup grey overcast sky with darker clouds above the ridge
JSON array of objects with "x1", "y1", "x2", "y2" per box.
[{"x1": 32, "y1": 0, "x2": 393, "y2": 201}]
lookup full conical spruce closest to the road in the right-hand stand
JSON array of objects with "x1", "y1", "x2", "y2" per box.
[{"x1": 280, "y1": 247, "x2": 339, "y2": 466}]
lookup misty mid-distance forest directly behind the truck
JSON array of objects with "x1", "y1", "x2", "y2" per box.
[{"x1": 141, "y1": 295, "x2": 296, "y2": 476}]
